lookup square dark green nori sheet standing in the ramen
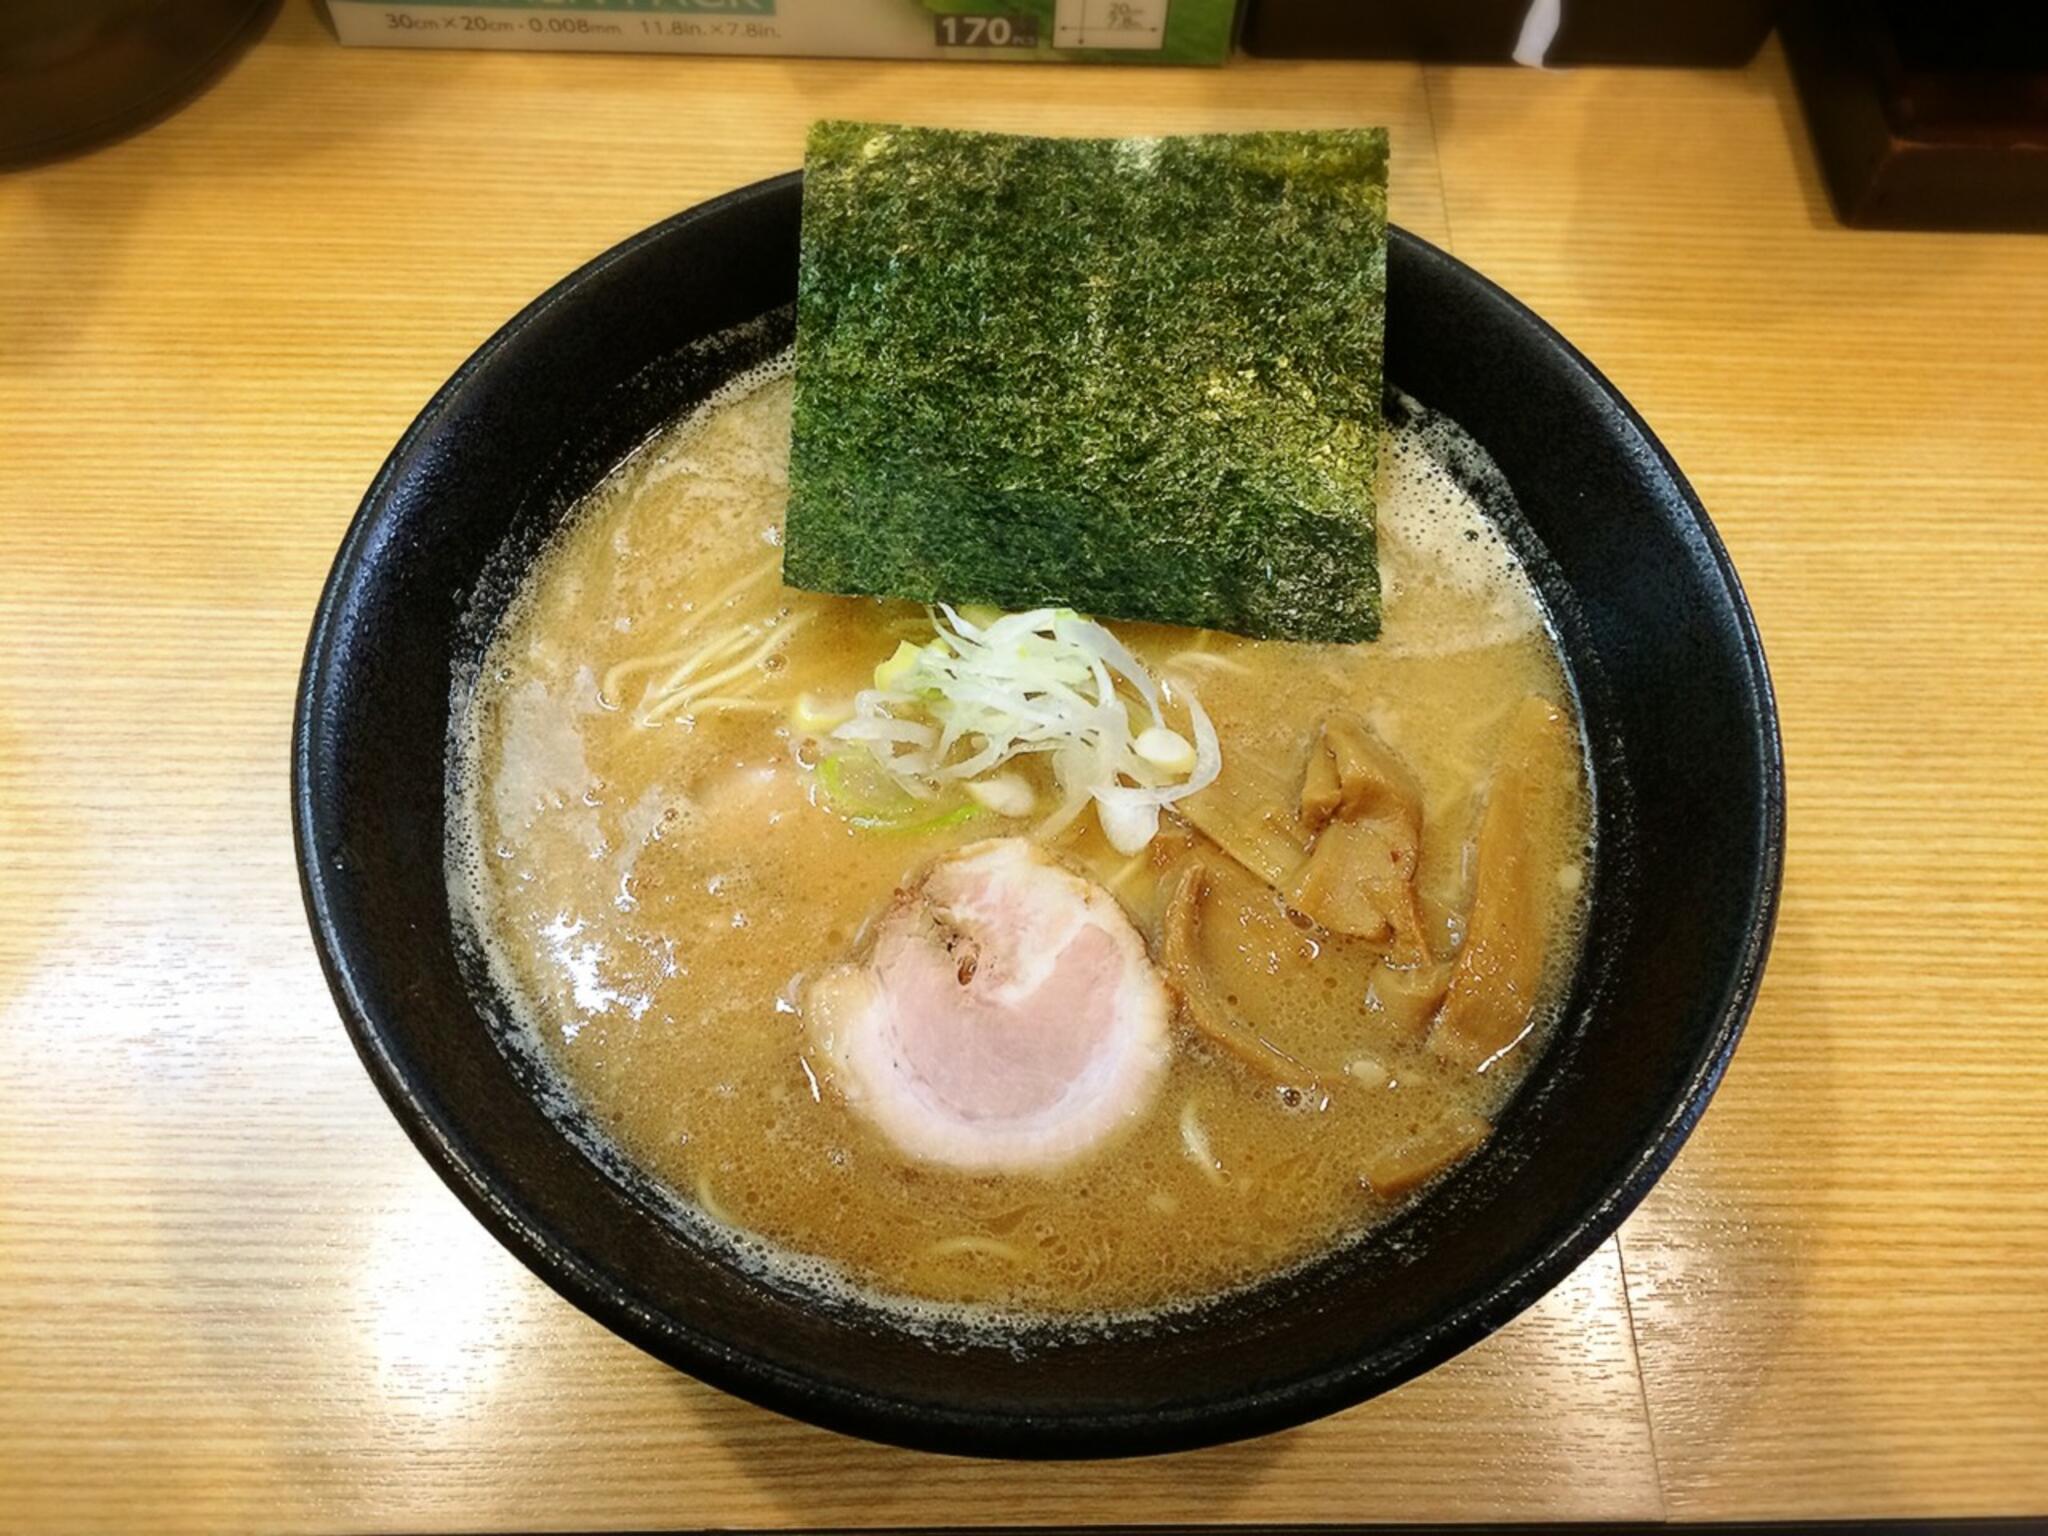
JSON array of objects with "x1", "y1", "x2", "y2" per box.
[{"x1": 782, "y1": 123, "x2": 1386, "y2": 641}]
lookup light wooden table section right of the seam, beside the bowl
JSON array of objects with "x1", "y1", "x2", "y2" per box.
[{"x1": 1430, "y1": 53, "x2": 2048, "y2": 1518}]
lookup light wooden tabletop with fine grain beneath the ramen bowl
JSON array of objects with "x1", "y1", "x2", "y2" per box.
[{"x1": 0, "y1": 0, "x2": 2048, "y2": 1530}]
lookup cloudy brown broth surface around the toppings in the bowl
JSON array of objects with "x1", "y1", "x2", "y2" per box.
[{"x1": 451, "y1": 358, "x2": 1587, "y2": 1317}]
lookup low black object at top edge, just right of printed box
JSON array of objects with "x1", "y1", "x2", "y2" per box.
[{"x1": 1243, "y1": 0, "x2": 1778, "y2": 66}]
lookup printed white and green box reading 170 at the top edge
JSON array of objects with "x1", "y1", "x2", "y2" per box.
[{"x1": 328, "y1": 0, "x2": 1237, "y2": 63}]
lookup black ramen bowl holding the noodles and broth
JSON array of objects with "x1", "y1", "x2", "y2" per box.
[{"x1": 293, "y1": 176, "x2": 1784, "y2": 1456}]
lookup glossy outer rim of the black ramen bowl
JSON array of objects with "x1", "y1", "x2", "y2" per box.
[{"x1": 291, "y1": 170, "x2": 1786, "y2": 1458}]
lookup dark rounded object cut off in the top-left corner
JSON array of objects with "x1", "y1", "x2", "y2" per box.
[{"x1": 0, "y1": 0, "x2": 279, "y2": 170}]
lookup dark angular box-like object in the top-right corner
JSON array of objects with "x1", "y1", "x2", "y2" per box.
[{"x1": 1780, "y1": 0, "x2": 2048, "y2": 229}]
